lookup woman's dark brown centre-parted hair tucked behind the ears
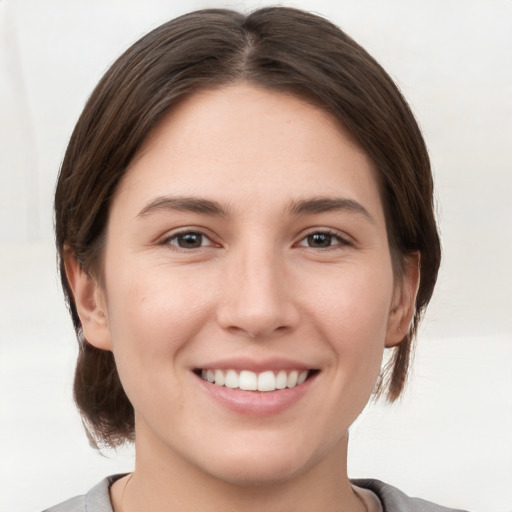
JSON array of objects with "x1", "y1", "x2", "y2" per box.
[{"x1": 55, "y1": 7, "x2": 440, "y2": 447}]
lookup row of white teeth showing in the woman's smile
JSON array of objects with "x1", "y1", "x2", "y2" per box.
[{"x1": 197, "y1": 370, "x2": 309, "y2": 391}]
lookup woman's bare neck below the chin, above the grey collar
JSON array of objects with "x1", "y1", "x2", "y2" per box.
[{"x1": 111, "y1": 434, "x2": 365, "y2": 512}]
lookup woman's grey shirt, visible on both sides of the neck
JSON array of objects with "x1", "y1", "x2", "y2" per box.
[{"x1": 45, "y1": 475, "x2": 470, "y2": 512}]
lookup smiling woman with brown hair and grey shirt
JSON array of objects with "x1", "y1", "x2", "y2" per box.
[{"x1": 50, "y1": 8, "x2": 464, "y2": 512}]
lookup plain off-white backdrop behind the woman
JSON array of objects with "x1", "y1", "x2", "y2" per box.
[{"x1": 0, "y1": 0, "x2": 512, "y2": 512}]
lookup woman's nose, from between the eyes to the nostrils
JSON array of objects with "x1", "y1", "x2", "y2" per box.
[{"x1": 217, "y1": 244, "x2": 300, "y2": 339}]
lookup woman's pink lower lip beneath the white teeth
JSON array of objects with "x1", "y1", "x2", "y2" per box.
[{"x1": 196, "y1": 375, "x2": 317, "y2": 417}]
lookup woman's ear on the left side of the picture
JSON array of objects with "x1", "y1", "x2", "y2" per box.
[{"x1": 64, "y1": 250, "x2": 112, "y2": 350}]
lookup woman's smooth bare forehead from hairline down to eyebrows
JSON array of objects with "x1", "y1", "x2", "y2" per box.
[{"x1": 112, "y1": 84, "x2": 380, "y2": 222}]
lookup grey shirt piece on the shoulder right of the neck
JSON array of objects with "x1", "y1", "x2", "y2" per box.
[{"x1": 352, "y1": 479, "x2": 472, "y2": 512}]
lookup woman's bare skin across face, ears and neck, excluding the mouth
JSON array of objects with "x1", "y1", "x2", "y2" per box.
[{"x1": 66, "y1": 83, "x2": 418, "y2": 512}]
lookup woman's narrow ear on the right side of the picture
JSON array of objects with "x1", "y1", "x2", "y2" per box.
[{"x1": 386, "y1": 252, "x2": 420, "y2": 347}]
